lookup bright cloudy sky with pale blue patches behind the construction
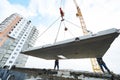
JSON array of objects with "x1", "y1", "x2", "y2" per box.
[{"x1": 0, "y1": 0, "x2": 120, "y2": 74}]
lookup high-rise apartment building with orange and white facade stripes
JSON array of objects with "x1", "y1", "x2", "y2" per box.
[{"x1": 0, "y1": 13, "x2": 38, "y2": 68}]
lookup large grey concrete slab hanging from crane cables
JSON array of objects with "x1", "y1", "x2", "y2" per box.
[{"x1": 22, "y1": 28, "x2": 119, "y2": 60}]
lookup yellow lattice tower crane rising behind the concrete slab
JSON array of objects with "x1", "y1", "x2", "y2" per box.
[{"x1": 73, "y1": 0, "x2": 102, "y2": 72}]
